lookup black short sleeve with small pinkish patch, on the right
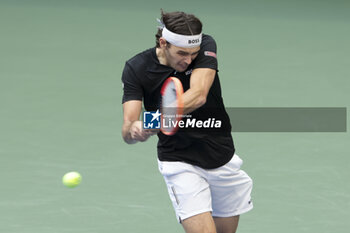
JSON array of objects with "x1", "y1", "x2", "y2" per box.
[{"x1": 193, "y1": 35, "x2": 218, "y2": 70}]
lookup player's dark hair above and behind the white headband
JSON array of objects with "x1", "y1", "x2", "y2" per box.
[{"x1": 156, "y1": 9, "x2": 203, "y2": 48}]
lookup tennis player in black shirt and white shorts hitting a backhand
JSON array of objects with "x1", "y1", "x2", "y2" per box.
[{"x1": 122, "y1": 11, "x2": 253, "y2": 233}]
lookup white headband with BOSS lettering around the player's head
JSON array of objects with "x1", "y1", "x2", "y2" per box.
[{"x1": 162, "y1": 26, "x2": 202, "y2": 48}]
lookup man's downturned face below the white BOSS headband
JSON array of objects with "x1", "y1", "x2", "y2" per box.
[{"x1": 164, "y1": 44, "x2": 200, "y2": 72}]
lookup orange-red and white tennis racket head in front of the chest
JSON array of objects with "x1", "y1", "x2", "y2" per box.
[{"x1": 160, "y1": 77, "x2": 183, "y2": 136}]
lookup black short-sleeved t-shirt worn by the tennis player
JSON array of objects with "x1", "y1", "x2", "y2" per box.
[{"x1": 122, "y1": 35, "x2": 235, "y2": 169}]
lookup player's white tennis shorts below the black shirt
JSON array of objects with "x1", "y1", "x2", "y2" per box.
[{"x1": 158, "y1": 155, "x2": 253, "y2": 222}]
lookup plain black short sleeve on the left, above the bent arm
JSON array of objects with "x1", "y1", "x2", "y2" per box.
[{"x1": 122, "y1": 63, "x2": 143, "y2": 103}]
